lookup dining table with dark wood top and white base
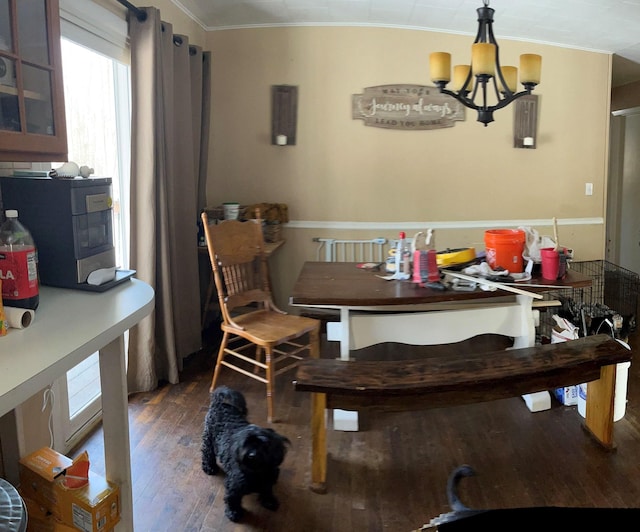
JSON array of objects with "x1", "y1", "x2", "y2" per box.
[{"x1": 289, "y1": 262, "x2": 591, "y2": 430}]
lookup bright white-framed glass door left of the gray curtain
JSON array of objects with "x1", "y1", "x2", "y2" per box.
[{"x1": 52, "y1": 0, "x2": 131, "y2": 452}]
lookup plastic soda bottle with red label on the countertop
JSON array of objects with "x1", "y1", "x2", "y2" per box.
[{"x1": 0, "y1": 209, "x2": 40, "y2": 310}]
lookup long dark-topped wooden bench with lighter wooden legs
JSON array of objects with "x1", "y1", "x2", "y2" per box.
[{"x1": 294, "y1": 334, "x2": 631, "y2": 493}]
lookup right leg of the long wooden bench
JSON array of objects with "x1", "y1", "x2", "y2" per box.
[{"x1": 584, "y1": 364, "x2": 616, "y2": 449}]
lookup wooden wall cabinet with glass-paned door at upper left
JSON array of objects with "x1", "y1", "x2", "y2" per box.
[{"x1": 0, "y1": 0, "x2": 67, "y2": 162}]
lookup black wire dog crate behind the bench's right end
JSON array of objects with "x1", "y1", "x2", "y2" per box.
[{"x1": 539, "y1": 260, "x2": 640, "y2": 338}]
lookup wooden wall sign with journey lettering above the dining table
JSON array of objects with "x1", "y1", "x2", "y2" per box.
[{"x1": 351, "y1": 84, "x2": 465, "y2": 129}]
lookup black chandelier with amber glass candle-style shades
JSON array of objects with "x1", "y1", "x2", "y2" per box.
[{"x1": 429, "y1": 0, "x2": 542, "y2": 127}]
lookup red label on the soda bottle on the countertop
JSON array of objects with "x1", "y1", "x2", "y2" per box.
[{"x1": 0, "y1": 247, "x2": 38, "y2": 301}]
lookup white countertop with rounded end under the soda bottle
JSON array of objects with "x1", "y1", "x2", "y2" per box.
[{"x1": 0, "y1": 279, "x2": 154, "y2": 416}]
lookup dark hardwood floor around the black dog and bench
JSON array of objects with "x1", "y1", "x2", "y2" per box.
[{"x1": 78, "y1": 326, "x2": 640, "y2": 532}]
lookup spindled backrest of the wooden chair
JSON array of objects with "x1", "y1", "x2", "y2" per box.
[{"x1": 202, "y1": 212, "x2": 273, "y2": 323}]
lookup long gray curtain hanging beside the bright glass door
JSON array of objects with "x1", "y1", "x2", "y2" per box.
[{"x1": 122, "y1": 8, "x2": 210, "y2": 393}]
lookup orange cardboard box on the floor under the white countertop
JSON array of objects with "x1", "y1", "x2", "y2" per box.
[{"x1": 20, "y1": 447, "x2": 120, "y2": 532}]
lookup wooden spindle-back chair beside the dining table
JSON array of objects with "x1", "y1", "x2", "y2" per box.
[{"x1": 202, "y1": 212, "x2": 320, "y2": 423}]
